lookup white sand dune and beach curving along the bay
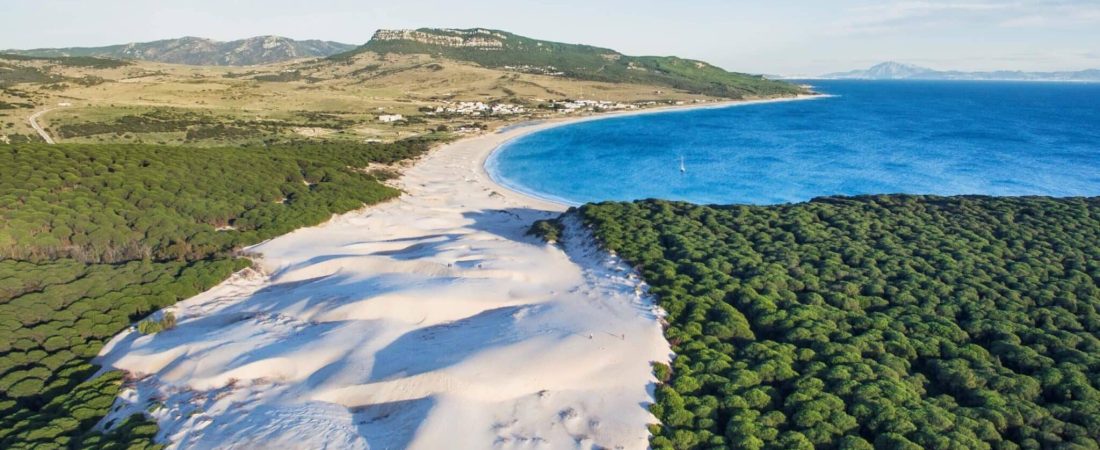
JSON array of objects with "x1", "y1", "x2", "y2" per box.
[{"x1": 98, "y1": 92, "x2": 818, "y2": 449}]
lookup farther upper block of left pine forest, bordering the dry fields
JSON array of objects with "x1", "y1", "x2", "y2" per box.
[{"x1": 0, "y1": 141, "x2": 430, "y2": 262}]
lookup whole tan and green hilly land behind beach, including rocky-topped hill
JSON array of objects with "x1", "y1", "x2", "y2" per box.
[{"x1": 0, "y1": 31, "x2": 804, "y2": 146}]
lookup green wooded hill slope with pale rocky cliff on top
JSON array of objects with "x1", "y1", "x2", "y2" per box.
[{"x1": 332, "y1": 29, "x2": 804, "y2": 98}]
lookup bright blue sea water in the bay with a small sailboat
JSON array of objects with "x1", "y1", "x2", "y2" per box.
[{"x1": 487, "y1": 80, "x2": 1100, "y2": 205}]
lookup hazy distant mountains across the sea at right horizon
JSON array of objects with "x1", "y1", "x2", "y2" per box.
[{"x1": 820, "y1": 63, "x2": 1100, "y2": 81}]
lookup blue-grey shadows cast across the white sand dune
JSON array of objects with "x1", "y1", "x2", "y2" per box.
[{"x1": 101, "y1": 204, "x2": 653, "y2": 448}]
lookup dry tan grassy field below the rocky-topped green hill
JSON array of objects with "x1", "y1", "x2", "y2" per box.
[{"x1": 0, "y1": 52, "x2": 774, "y2": 146}]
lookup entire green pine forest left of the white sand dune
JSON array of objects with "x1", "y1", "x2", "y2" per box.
[{"x1": 0, "y1": 139, "x2": 442, "y2": 449}]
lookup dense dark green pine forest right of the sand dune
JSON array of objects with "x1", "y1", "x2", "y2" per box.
[{"x1": 579, "y1": 196, "x2": 1100, "y2": 449}]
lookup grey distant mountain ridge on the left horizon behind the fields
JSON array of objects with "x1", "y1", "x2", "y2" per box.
[{"x1": 0, "y1": 36, "x2": 356, "y2": 66}]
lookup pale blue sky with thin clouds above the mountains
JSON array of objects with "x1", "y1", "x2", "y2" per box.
[{"x1": 0, "y1": 0, "x2": 1100, "y2": 75}]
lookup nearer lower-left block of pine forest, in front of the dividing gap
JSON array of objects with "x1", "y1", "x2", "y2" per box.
[{"x1": 0, "y1": 259, "x2": 242, "y2": 449}]
